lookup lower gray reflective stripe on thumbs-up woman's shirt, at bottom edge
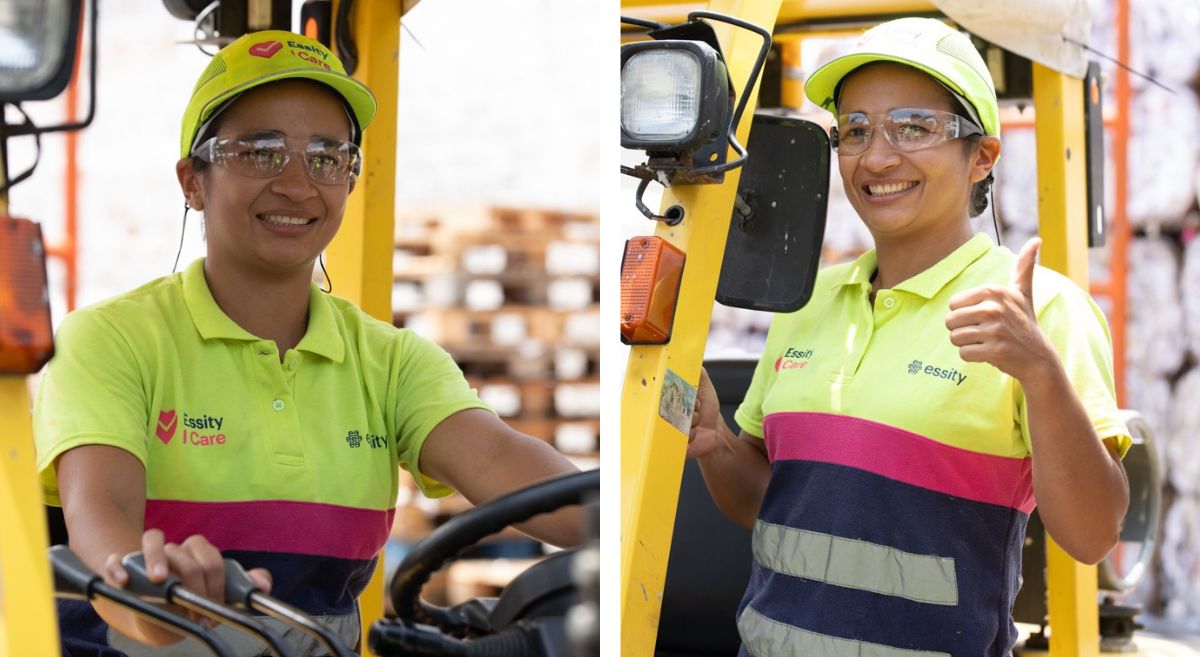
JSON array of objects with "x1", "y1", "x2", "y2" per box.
[{"x1": 738, "y1": 607, "x2": 950, "y2": 657}]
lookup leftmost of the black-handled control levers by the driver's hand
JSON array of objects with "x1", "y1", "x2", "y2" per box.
[{"x1": 50, "y1": 546, "x2": 236, "y2": 657}]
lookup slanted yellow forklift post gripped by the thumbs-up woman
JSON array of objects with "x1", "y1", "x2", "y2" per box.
[{"x1": 620, "y1": 0, "x2": 780, "y2": 657}]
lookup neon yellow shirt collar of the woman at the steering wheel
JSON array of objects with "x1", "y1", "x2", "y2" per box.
[{"x1": 182, "y1": 258, "x2": 346, "y2": 362}]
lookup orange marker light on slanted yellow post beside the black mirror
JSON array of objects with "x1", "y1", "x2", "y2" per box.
[{"x1": 620, "y1": 236, "x2": 686, "y2": 344}]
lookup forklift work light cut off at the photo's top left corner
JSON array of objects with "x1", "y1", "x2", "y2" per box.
[{"x1": 0, "y1": 0, "x2": 80, "y2": 103}]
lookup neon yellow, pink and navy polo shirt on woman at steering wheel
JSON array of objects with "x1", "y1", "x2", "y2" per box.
[{"x1": 35, "y1": 259, "x2": 486, "y2": 615}]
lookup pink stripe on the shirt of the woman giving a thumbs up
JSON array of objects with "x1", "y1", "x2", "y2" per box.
[{"x1": 763, "y1": 412, "x2": 1034, "y2": 513}]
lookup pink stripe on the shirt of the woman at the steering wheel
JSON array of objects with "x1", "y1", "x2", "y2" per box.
[{"x1": 145, "y1": 500, "x2": 396, "y2": 559}]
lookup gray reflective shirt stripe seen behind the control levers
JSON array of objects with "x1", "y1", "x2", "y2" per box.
[{"x1": 108, "y1": 610, "x2": 362, "y2": 657}]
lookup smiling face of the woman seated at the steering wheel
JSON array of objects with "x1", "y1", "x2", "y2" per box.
[{"x1": 180, "y1": 80, "x2": 354, "y2": 275}]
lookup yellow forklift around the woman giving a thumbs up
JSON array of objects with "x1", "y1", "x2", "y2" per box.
[{"x1": 619, "y1": 0, "x2": 1198, "y2": 657}]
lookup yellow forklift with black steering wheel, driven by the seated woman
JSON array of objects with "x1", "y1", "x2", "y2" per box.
[{"x1": 0, "y1": 0, "x2": 599, "y2": 657}]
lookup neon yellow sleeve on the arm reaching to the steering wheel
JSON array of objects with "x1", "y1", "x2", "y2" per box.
[{"x1": 395, "y1": 331, "x2": 491, "y2": 498}]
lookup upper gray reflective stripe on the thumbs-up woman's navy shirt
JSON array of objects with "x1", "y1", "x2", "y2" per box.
[{"x1": 754, "y1": 520, "x2": 959, "y2": 605}]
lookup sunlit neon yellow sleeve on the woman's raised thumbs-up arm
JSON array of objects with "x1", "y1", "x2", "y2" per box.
[{"x1": 1019, "y1": 279, "x2": 1133, "y2": 457}]
